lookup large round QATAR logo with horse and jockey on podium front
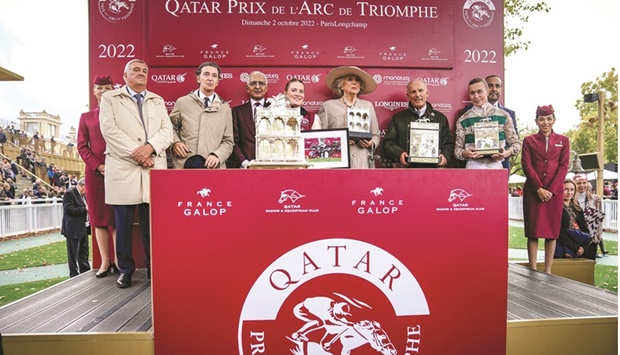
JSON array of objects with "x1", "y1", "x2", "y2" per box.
[{"x1": 238, "y1": 238, "x2": 430, "y2": 355}]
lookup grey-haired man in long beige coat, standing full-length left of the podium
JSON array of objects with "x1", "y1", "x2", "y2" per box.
[{"x1": 99, "y1": 59, "x2": 172, "y2": 288}]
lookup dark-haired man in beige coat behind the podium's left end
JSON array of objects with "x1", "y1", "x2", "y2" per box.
[{"x1": 170, "y1": 62, "x2": 234, "y2": 169}]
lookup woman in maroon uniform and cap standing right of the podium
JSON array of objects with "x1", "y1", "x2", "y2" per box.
[{"x1": 521, "y1": 105, "x2": 570, "y2": 274}]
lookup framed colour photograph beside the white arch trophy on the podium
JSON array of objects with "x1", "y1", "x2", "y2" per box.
[{"x1": 301, "y1": 128, "x2": 350, "y2": 169}]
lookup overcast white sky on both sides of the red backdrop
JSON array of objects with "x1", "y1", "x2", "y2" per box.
[{"x1": 0, "y1": 0, "x2": 620, "y2": 135}]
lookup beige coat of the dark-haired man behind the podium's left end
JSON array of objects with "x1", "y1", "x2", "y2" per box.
[{"x1": 170, "y1": 92, "x2": 234, "y2": 169}]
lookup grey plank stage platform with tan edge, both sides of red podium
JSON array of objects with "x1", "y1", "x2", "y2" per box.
[{"x1": 0, "y1": 263, "x2": 618, "y2": 355}]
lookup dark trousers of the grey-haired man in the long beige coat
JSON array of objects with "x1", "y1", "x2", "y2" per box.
[{"x1": 114, "y1": 203, "x2": 151, "y2": 275}]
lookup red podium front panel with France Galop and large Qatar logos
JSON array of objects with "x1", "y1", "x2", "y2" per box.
[{"x1": 151, "y1": 169, "x2": 508, "y2": 355}]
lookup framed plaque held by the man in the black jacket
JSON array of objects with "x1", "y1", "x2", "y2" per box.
[{"x1": 407, "y1": 122, "x2": 440, "y2": 165}]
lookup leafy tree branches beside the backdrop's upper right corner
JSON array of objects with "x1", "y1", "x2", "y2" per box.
[{"x1": 504, "y1": 0, "x2": 551, "y2": 57}]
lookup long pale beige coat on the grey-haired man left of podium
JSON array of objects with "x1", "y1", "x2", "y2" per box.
[{"x1": 99, "y1": 86, "x2": 172, "y2": 205}]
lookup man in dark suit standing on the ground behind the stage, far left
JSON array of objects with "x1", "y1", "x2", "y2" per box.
[{"x1": 60, "y1": 179, "x2": 90, "y2": 277}]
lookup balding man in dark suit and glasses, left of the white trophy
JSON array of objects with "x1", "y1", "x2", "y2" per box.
[{"x1": 226, "y1": 71, "x2": 269, "y2": 169}]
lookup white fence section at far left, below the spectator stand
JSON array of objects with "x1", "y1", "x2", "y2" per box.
[{"x1": 0, "y1": 198, "x2": 62, "y2": 238}]
